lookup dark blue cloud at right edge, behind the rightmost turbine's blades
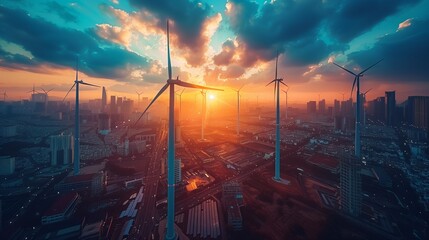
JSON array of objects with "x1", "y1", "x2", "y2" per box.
[{"x1": 348, "y1": 19, "x2": 429, "y2": 83}]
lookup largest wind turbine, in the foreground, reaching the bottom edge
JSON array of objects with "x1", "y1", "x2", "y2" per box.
[{"x1": 134, "y1": 20, "x2": 223, "y2": 239}]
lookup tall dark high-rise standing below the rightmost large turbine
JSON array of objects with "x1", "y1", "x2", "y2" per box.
[{"x1": 340, "y1": 152, "x2": 362, "y2": 216}]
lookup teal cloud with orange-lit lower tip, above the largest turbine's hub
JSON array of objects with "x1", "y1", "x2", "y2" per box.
[{"x1": 130, "y1": 0, "x2": 210, "y2": 66}]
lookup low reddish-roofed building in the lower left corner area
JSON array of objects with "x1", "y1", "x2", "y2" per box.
[{"x1": 42, "y1": 192, "x2": 80, "y2": 225}]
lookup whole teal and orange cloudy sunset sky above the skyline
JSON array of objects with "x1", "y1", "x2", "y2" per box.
[{"x1": 0, "y1": 0, "x2": 429, "y2": 103}]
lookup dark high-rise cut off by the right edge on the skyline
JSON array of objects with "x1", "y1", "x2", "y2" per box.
[{"x1": 405, "y1": 96, "x2": 429, "y2": 131}]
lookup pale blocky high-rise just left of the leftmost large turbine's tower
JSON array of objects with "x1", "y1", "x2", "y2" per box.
[{"x1": 50, "y1": 134, "x2": 74, "y2": 166}]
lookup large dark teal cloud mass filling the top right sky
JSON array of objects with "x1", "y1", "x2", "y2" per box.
[{"x1": 226, "y1": 0, "x2": 420, "y2": 66}]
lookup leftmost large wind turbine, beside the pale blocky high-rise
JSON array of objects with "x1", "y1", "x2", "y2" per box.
[{"x1": 63, "y1": 59, "x2": 100, "y2": 176}]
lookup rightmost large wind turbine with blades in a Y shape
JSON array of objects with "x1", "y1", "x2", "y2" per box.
[{"x1": 333, "y1": 59, "x2": 383, "y2": 158}]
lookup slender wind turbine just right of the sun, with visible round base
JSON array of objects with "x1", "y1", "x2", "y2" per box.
[{"x1": 266, "y1": 53, "x2": 288, "y2": 184}]
